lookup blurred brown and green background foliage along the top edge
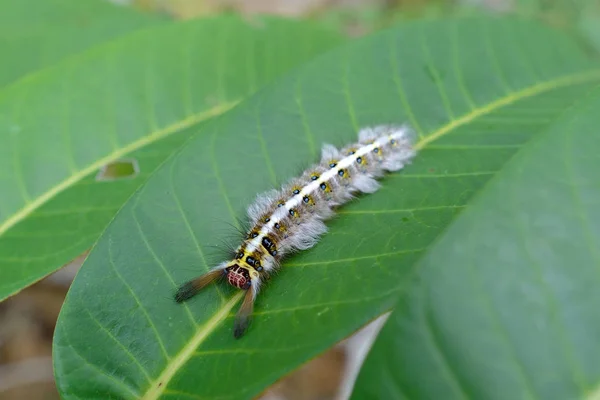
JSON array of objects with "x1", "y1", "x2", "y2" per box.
[{"x1": 129, "y1": 0, "x2": 600, "y2": 50}]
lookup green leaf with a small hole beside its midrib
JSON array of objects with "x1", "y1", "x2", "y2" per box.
[{"x1": 0, "y1": 17, "x2": 341, "y2": 300}]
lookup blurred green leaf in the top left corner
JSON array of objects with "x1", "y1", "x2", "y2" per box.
[{"x1": 0, "y1": 0, "x2": 166, "y2": 90}]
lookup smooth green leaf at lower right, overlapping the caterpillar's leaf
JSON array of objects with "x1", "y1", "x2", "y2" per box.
[{"x1": 353, "y1": 84, "x2": 600, "y2": 400}]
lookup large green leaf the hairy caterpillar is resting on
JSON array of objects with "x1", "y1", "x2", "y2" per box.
[{"x1": 54, "y1": 18, "x2": 600, "y2": 399}]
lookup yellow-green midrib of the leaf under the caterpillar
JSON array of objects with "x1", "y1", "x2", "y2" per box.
[{"x1": 141, "y1": 69, "x2": 600, "y2": 400}]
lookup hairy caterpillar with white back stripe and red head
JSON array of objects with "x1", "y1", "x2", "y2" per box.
[{"x1": 175, "y1": 125, "x2": 416, "y2": 339}]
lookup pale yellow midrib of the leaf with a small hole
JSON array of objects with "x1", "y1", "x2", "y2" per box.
[{"x1": 0, "y1": 99, "x2": 241, "y2": 237}]
